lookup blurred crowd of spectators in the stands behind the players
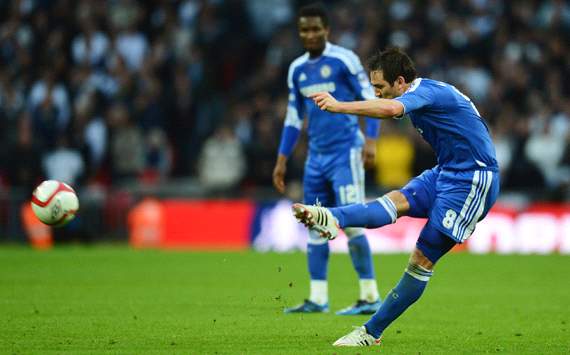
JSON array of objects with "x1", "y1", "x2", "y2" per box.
[{"x1": 0, "y1": 0, "x2": 570, "y2": 199}]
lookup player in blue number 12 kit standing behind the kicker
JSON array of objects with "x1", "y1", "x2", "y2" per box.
[{"x1": 273, "y1": 5, "x2": 381, "y2": 315}]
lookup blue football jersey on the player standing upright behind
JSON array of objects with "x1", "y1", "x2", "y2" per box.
[{"x1": 285, "y1": 43, "x2": 377, "y2": 153}]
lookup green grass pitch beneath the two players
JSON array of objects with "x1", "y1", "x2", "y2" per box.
[{"x1": 0, "y1": 246, "x2": 570, "y2": 354}]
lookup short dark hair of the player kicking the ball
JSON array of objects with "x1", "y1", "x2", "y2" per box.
[{"x1": 368, "y1": 47, "x2": 417, "y2": 85}]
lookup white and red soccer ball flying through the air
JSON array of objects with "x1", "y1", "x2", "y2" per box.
[{"x1": 31, "y1": 180, "x2": 79, "y2": 227}]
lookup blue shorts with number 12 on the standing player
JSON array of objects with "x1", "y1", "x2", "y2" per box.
[{"x1": 303, "y1": 146, "x2": 364, "y2": 207}]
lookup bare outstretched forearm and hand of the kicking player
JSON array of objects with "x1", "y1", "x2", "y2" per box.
[{"x1": 310, "y1": 92, "x2": 404, "y2": 118}]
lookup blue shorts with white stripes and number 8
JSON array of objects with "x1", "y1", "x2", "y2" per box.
[{"x1": 401, "y1": 166, "x2": 500, "y2": 243}]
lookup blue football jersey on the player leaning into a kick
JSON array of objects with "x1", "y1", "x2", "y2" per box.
[{"x1": 396, "y1": 78, "x2": 498, "y2": 171}]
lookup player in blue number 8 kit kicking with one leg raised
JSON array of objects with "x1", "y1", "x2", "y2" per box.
[{"x1": 293, "y1": 48, "x2": 499, "y2": 346}]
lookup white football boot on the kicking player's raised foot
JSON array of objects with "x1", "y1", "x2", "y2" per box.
[{"x1": 292, "y1": 203, "x2": 340, "y2": 240}]
